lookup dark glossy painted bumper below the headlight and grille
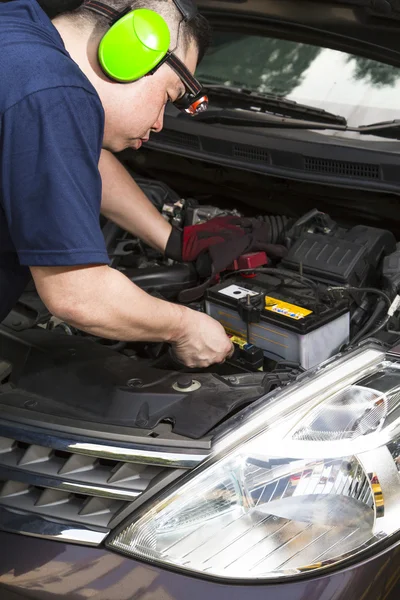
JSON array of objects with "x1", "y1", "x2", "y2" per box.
[{"x1": 0, "y1": 533, "x2": 400, "y2": 600}]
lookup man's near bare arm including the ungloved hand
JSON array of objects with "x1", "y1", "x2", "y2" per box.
[{"x1": 31, "y1": 265, "x2": 232, "y2": 367}]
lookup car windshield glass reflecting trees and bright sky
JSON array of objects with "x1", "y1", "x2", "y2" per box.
[{"x1": 197, "y1": 31, "x2": 400, "y2": 126}]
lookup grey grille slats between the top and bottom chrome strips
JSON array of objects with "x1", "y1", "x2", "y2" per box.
[{"x1": 0, "y1": 438, "x2": 162, "y2": 527}]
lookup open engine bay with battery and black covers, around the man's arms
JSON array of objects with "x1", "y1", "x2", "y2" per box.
[{"x1": 0, "y1": 166, "x2": 400, "y2": 441}]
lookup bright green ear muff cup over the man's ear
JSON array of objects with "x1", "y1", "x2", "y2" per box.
[{"x1": 99, "y1": 8, "x2": 170, "y2": 83}]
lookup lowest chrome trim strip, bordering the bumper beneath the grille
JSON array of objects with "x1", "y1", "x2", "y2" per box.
[{"x1": 0, "y1": 506, "x2": 109, "y2": 546}]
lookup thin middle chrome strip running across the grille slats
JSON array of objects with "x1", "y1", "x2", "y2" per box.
[{"x1": 0, "y1": 464, "x2": 142, "y2": 506}]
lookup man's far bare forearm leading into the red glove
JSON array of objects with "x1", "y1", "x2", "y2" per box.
[{"x1": 99, "y1": 150, "x2": 172, "y2": 252}]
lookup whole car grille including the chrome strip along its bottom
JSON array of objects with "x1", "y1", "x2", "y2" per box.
[{"x1": 0, "y1": 430, "x2": 198, "y2": 545}]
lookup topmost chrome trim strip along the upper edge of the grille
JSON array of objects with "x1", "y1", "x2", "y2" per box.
[{"x1": 0, "y1": 420, "x2": 209, "y2": 469}]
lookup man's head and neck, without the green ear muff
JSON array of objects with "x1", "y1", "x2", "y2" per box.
[{"x1": 53, "y1": 0, "x2": 210, "y2": 151}]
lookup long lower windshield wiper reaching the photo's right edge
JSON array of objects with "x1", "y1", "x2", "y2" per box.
[{"x1": 194, "y1": 109, "x2": 400, "y2": 140}]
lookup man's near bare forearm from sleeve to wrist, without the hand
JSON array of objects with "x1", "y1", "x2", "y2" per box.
[{"x1": 31, "y1": 266, "x2": 188, "y2": 342}]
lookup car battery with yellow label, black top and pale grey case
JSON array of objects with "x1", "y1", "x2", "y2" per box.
[{"x1": 206, "y1": 275, "x2": 350, "y2": 369}]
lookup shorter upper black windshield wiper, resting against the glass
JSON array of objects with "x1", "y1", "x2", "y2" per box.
[{"x1": 205, "y1": 85, "x2": 346, "y2": 125}]
